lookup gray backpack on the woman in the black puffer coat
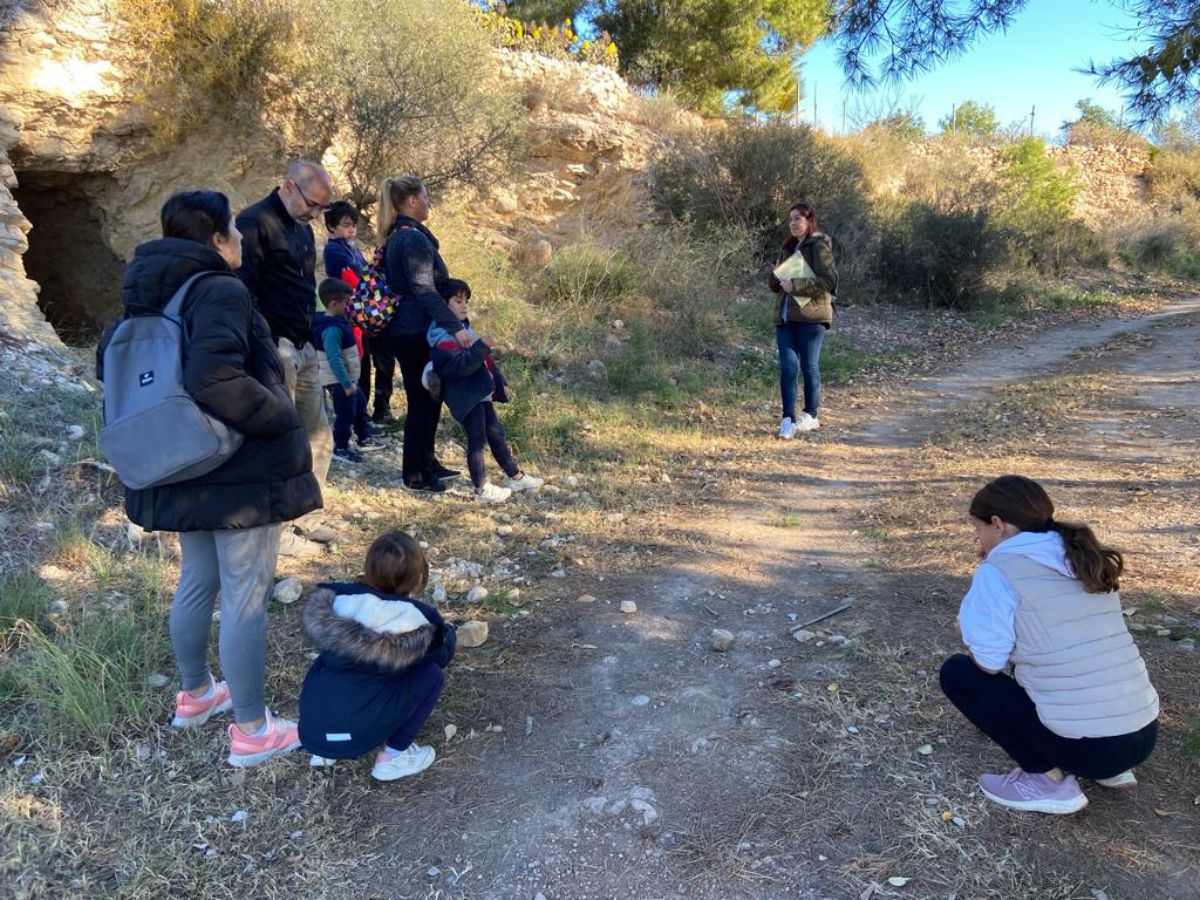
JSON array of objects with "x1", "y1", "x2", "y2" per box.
[{"x1": 100, "y1": 272, "x2": 242, "y2": 490}]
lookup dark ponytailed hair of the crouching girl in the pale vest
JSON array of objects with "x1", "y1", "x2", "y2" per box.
[{"x1": 970, "y1": 475, "x2": 1124, "y2": 594}]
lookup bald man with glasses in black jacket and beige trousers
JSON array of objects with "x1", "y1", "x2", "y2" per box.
[{"x1": 238, "y1": 160, "x2": 336, "y2": 556}]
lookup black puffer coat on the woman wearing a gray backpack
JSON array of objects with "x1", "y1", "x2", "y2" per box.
[{"x1": 97, "y1": 238, "x2": 322, "y2": 532}]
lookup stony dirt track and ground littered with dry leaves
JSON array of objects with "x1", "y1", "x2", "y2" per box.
[{"x1": 0, "y1": 290, "x2": 1200, "y2": 900}]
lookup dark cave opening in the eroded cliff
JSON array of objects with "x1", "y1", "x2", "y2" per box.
[{"x1": 13, "y1": 169, "x2": 125, "y2": 347}]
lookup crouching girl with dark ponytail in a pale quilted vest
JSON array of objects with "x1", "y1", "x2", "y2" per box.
[{"x1": 941, "y1": 475, "x2": 1158, "y2": 814}]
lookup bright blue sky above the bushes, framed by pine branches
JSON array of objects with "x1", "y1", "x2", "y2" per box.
[{"x1": 802, "y1": 0, "x2": 1141, "y2": 134}]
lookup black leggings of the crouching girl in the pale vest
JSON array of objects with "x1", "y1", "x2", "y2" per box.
[{"x1": 941, "y1": 653, "x2": 1158, "y2": 779}]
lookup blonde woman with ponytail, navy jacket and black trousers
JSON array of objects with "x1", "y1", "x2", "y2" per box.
[{"x1": 378, "y1": 175, "x2": 475, "y2": 493}]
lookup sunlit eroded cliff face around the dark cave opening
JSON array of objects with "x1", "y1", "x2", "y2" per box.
[{"x1": 0, "y1": 0, "x2": 309, "y2": 342}]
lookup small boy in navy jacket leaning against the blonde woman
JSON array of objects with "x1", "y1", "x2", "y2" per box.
[{"x1": 426, "y1": 278, "x2": 544, "y2": 503}]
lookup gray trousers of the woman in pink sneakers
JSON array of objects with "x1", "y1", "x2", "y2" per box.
[{"x1": 170, "y1": 524, "x2": 282, "y2": 722}]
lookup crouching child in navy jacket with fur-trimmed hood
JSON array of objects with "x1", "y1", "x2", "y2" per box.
[{"x1": 300, "y1": 532, "x2": 455, "y2": 781}]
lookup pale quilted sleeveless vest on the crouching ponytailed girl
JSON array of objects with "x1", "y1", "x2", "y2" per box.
[{"x1": 988, "y1": 554, "x2": 1158, "y2": 738}]
